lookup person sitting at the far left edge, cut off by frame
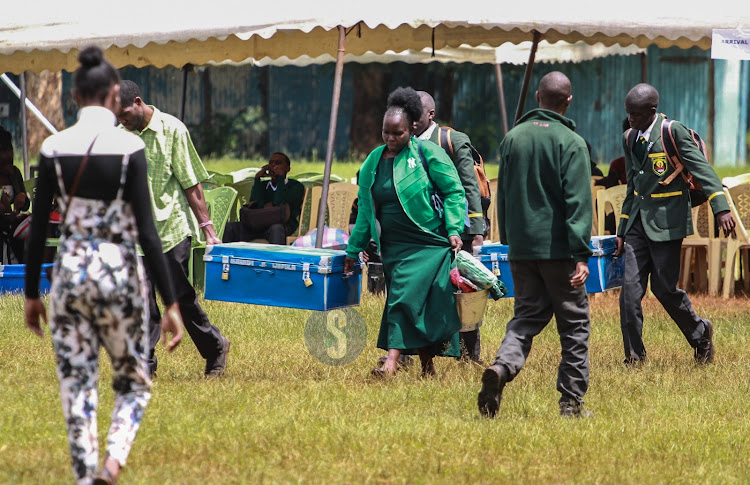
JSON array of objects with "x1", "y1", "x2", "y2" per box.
[{"x1": 0, "y1": 126, "x2": 30, "y2": 264}]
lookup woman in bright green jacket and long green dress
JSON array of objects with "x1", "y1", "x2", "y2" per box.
[{"x1": 344, "y1": 88, "x2": 466, "y2": 377}]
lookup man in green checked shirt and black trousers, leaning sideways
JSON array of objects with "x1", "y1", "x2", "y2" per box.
[{"x1": 117, "y1": 80, "x2": 229, "y2": 377}]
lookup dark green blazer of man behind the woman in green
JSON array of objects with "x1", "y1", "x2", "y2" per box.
[{"x1": 430, "y1": 125, "x2": 484, "y2": 239}]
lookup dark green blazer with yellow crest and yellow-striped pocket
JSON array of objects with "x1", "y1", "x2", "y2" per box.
[{"x1": 617, "y1": 114, "x2": 729, "y2": 241}]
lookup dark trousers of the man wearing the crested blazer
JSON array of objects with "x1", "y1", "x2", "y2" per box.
[{"x1": 620, "y1": 215, "x2": 706, "y2": 360}]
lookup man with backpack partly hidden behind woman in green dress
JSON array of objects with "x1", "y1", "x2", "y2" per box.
[{"x1": 414, "y1": 91, "x2": 484, "y2": 364}]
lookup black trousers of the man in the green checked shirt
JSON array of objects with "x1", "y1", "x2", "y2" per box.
[{"x1": 141, "y1": 237, "x2": 222, "y2": 372}]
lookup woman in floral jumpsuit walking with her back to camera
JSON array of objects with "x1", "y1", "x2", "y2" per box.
[{"x1": 25, "y1": 47, "x2": 182, "y2": 484}]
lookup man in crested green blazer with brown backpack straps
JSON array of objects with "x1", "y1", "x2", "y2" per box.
[{"x1": 616, "y1": 83, "x2": 735, "y2": 366}]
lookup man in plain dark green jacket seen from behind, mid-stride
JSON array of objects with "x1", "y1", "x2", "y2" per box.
[{"x1": 477, "y1": 71, "x2": 593, "y2": 417}]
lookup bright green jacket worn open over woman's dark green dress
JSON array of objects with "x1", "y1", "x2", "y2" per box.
[{"x1": 346, "y1": 137, "x2": 466, "y2": 258}]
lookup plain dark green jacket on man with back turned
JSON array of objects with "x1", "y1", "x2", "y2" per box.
[{"x1": 497, "y1": 109, "x2": 592, "y2": 261}]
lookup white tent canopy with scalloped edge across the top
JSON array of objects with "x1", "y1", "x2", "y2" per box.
[{"x1": 0, "y1": 0, "x2": 750, "y2": 73}]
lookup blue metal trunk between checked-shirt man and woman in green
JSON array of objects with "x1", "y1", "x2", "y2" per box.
[{"x1": 203, "y1": 242, "x2": 362, "y2": 311}]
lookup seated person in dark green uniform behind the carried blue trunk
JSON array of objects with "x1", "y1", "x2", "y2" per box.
[{"x1": 222, "y1": 152, "x2": 305, "y2": 245}]
